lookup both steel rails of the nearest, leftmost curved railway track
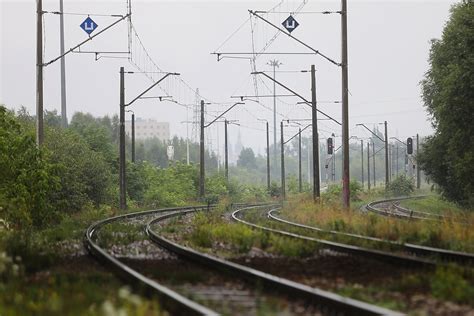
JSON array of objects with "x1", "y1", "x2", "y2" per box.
[{"x1": 84, "y1": 206, "x2": 400, "y2": 315}]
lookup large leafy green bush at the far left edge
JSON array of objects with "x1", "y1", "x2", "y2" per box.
[{"x1": 0, "y1": 106, "x2": 59, "y2": 228}]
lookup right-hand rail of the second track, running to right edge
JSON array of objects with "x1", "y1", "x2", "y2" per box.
[{"x1": 267, "y1": 209, "x2": 474, "y2": 264}]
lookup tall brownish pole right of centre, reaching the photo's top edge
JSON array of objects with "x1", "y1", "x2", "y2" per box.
[{"x1": 341, "y1": 0, "x2": 351, "y2": 208}]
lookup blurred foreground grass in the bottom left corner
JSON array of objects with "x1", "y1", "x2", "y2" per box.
[{"x1": 0, "y1": 271, "x2": 163, "y2": 315}]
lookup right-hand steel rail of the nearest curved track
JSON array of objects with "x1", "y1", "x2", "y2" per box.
[{"x1": 146, "y1": 205, "x2": 402, "y2": 315}]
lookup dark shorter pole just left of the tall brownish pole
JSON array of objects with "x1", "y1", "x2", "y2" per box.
[{"x1": 311, "y1": 65, "x2": 321, "y2": 201}]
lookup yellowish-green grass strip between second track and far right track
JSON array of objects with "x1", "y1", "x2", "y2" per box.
[{"x1": 281, "y1": 194, "x2": 474, "y2": 252}]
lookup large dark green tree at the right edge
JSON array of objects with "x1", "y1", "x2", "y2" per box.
[{"x1": 417, "y1": 0, "x2": 474, "y2": 207}]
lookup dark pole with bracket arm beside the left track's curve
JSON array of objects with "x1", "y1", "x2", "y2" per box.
[{"x1": 119, "y1": 67, "x2": 127, "y2": 210}]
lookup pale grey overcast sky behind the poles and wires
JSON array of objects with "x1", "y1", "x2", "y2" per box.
[{"x1": 0, "y1": 0, "x2": 454, "y2": 157}]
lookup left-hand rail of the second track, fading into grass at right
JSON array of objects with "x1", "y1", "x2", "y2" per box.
[{"x1": 232, "y1": 208, "x2": 436, "y2": 269}]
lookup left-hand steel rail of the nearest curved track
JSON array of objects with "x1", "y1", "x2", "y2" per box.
[{"x1": 84, "y1": 205, "x2": 218, "y2": 315}]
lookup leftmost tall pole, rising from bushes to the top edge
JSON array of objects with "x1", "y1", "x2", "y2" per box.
[{"x1": 36, "y1": 0, "x2": 44, "y2": 146}]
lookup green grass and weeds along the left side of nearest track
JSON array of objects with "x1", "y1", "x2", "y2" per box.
[{"x1": 0, "y1": 207, "x2": 169, "y2": 315}]
